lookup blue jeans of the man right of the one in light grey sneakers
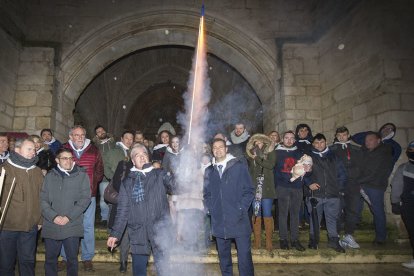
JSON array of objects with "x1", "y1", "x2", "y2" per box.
[{"x1": 364, "y1": 187, "x2": 387, "y2": 242}]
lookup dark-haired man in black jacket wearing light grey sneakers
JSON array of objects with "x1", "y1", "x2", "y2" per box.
[{"x1": 330, "y1": 126, "x2": 362, "y2": 249}]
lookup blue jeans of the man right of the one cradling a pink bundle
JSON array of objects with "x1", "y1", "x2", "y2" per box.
[{"x1": 306, "y1": 197, "x2": 341, "y2": 238}]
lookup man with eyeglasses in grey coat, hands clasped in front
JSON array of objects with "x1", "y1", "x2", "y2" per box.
[{"x1": 40, "y1": 148, "x2": 91, "y2": 275}]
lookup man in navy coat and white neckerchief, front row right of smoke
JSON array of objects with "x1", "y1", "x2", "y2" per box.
[{"x1": 204, "y1": 139, "x2": 254, "y2": 276}]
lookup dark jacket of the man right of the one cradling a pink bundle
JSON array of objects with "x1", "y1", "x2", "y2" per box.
[{"x1": 308, "y1": 148, "x2": 347, "y2": 198}]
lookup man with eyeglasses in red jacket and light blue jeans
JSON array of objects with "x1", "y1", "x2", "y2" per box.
[{"x1": 58, "y1": 125, "x2": 104, "y2": 271}]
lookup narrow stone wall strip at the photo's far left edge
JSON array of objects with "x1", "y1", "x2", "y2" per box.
[{"x1": 0, "y1": 29, "x2": 20, "y2": 131}]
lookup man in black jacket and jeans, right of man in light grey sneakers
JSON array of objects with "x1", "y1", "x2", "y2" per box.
[{"x1": 359, "y1": 131, "x2": 394, "y2": 245}]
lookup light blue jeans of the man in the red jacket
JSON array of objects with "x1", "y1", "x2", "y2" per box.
[{"x1": 60, "y1": 197, "x2": 96, "y2": 261}]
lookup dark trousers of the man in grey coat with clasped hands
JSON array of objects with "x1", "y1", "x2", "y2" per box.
[{"x1": 45, "y1": 237, "x2": 79, "y2": 276}]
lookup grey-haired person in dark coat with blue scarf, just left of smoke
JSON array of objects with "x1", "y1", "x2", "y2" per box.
[{"x1": 107, "y1": 144, "x2": 175, "y2": 275}]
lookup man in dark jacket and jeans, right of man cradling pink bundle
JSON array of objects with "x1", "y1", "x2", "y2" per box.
[{"x1": 307, "y1": 133, "x2": 346, "y2": 253}]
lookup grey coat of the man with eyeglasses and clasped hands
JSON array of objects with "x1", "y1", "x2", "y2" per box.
[{"x1": 40, "y1": 165, "x2": 91, "y2": 240}]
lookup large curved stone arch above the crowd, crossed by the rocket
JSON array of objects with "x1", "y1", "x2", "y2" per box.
[{"x1": 52, "y1": 10, "x2": 278, "y2": 138}]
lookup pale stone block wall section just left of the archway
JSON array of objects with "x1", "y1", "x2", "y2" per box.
[{"x1": 13, "y1": 47, "x2": 54, "y2": 134}]
